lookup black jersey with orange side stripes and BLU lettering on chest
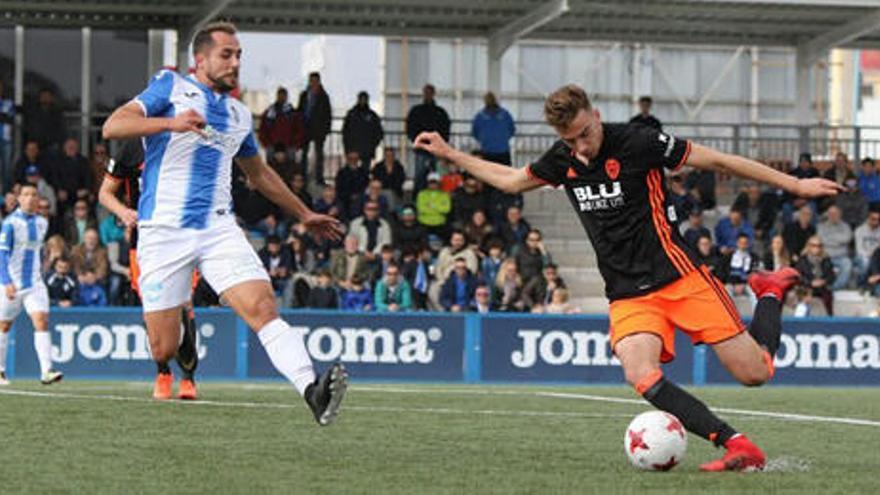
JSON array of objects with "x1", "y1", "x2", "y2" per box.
[{"x1": 526, "y1": 124, "x2": 699, "y2": 301}]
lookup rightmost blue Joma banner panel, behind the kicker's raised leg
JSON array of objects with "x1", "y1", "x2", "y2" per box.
[{"x1": 706, "y1": 318, "x2": 880, "y2": 385}]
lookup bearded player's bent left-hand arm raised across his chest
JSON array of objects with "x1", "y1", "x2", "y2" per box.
[{"x1": 102, "y1": 101, "x2": 205, "y2": 139}]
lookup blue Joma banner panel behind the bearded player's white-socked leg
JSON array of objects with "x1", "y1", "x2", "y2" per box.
[{"x1": 247, "y1": 311, "x2": 465, "y2": 381}]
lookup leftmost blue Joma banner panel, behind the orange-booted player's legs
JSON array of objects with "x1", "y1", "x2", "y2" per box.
[{"x1": 10, "y1": 308, "x2": 236, "y2": 378}]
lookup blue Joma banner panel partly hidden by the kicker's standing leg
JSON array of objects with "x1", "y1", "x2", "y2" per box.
[{"x1": 480, "y1": 315, "x2": 693, "y2": 384}]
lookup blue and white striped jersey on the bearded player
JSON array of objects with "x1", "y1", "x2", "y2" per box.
[{"x1": 134, "y1": 70, "x2": 258, "y2": 229}]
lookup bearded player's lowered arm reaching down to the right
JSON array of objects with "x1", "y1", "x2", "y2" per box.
[{"x1": 236, "y1": 155, "x2": 342, "y2": 240}]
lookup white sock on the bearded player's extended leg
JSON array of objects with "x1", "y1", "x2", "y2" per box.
[{"x1": 257, "y1": 318, "x2": 315, "y2": 395}]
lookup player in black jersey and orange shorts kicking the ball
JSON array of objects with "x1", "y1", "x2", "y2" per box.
[{"x1": 415, "y1": 85, "x2": 842, "y2": 471}]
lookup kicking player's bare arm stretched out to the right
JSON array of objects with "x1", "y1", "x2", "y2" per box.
[{"x1": 686, "y1": 143, "x2": 845, "y2": 198}]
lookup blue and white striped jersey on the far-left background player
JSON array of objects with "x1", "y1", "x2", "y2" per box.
[{"x1": 0, "y1": 209, "x2": 49, "y2": 290}]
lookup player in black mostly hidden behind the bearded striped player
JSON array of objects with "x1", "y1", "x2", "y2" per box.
[{"x1": 98, "y1": 139, "x2": 199, "y2": 400}]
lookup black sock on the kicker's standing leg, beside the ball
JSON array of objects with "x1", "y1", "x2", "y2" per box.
[{"x1": 642, "y1": 378, "x2": 736, "y2": 447}]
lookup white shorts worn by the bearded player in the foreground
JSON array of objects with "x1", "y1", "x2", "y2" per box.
[{"x1": 137, "y1": 216, "x2": 269, "y2": 312}]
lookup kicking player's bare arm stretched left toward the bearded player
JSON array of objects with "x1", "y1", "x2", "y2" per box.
[{"x1": 413, "y1": 132, "x2": 544, "y2": 194}]
